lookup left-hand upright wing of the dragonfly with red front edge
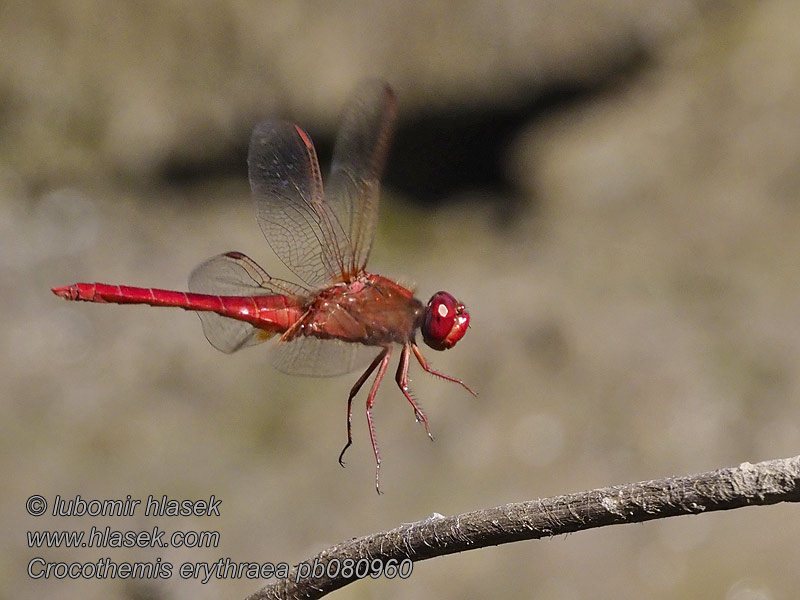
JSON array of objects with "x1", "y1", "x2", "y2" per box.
[{"x1": 247, "y1": 120, "x2": 349, "y2": 287}]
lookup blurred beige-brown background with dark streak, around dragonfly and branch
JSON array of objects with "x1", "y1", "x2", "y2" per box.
[{"x1": 0, "y1": 0, "x2": 800, "y2": 600}]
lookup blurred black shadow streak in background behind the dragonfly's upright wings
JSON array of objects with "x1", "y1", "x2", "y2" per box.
[{"x1": 162, "y1": 44, "x2": 648, "y2": 225}]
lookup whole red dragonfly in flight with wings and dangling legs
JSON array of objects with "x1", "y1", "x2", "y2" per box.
[{"x1": 53, "y1": 80, "x2": 474, "y2": 493}]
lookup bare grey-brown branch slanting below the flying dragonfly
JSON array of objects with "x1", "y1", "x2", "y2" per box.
[{"x1": 247, "y1": 456, "x2": 800, "y2": 600}]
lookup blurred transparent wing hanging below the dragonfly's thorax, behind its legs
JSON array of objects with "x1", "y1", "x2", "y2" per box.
[{"x1": 271, "y1": 337, "x2": 381, "y2": 376}]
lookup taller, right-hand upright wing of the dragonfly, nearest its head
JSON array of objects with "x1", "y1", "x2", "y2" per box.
[{"x1": 326, "y1": 80, "x2": 396, "y2": 274}]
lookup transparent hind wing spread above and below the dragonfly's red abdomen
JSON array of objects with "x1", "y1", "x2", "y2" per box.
[{"x1": 189, "y1": 252, "x2": 305, "y2": 353}]
